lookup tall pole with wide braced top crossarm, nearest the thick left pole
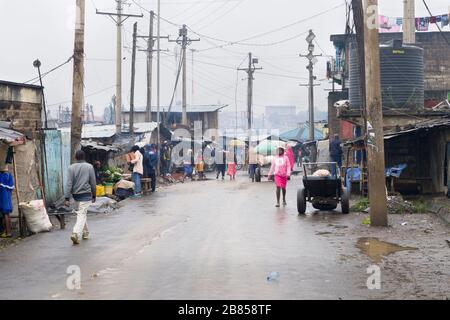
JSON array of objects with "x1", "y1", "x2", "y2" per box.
[{"x1": 97, "y1": 0, "x2": 144, "y2": 134}]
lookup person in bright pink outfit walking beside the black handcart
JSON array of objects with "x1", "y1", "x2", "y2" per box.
[{"x1": 269, "y1": 147, "x2": 292, "y2": 208}]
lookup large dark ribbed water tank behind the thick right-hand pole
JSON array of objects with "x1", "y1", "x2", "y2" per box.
[{"x1": 349, "y1": 40, "x2": 424, "y2": 109}]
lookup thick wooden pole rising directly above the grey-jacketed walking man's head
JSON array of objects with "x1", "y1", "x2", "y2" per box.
[{"x1": 70, "y1": 0, "x2": 85, "y2": 163}]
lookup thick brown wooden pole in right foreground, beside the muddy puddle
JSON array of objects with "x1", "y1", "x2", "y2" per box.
[{"x1": 361, "y1": 0, "x2": 388, "y2": 227}]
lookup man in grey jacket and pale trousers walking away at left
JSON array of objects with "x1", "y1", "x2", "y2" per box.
[{"x1": 65, "y1": 150, "x2": 97, "y2": 245}]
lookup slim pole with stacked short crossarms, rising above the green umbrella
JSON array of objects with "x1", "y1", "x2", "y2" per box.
[{"x1": 300, "y1": 30, "x2": 322, "y2": 141}]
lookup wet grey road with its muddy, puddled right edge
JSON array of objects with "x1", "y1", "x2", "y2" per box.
[{"x1": 0, "y1": 172, "x2": 450, "y2": 299}]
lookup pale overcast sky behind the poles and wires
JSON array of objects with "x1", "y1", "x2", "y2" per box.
[{"x1": 0, "y1": 0, "x2": 449, "y2": 120}]
